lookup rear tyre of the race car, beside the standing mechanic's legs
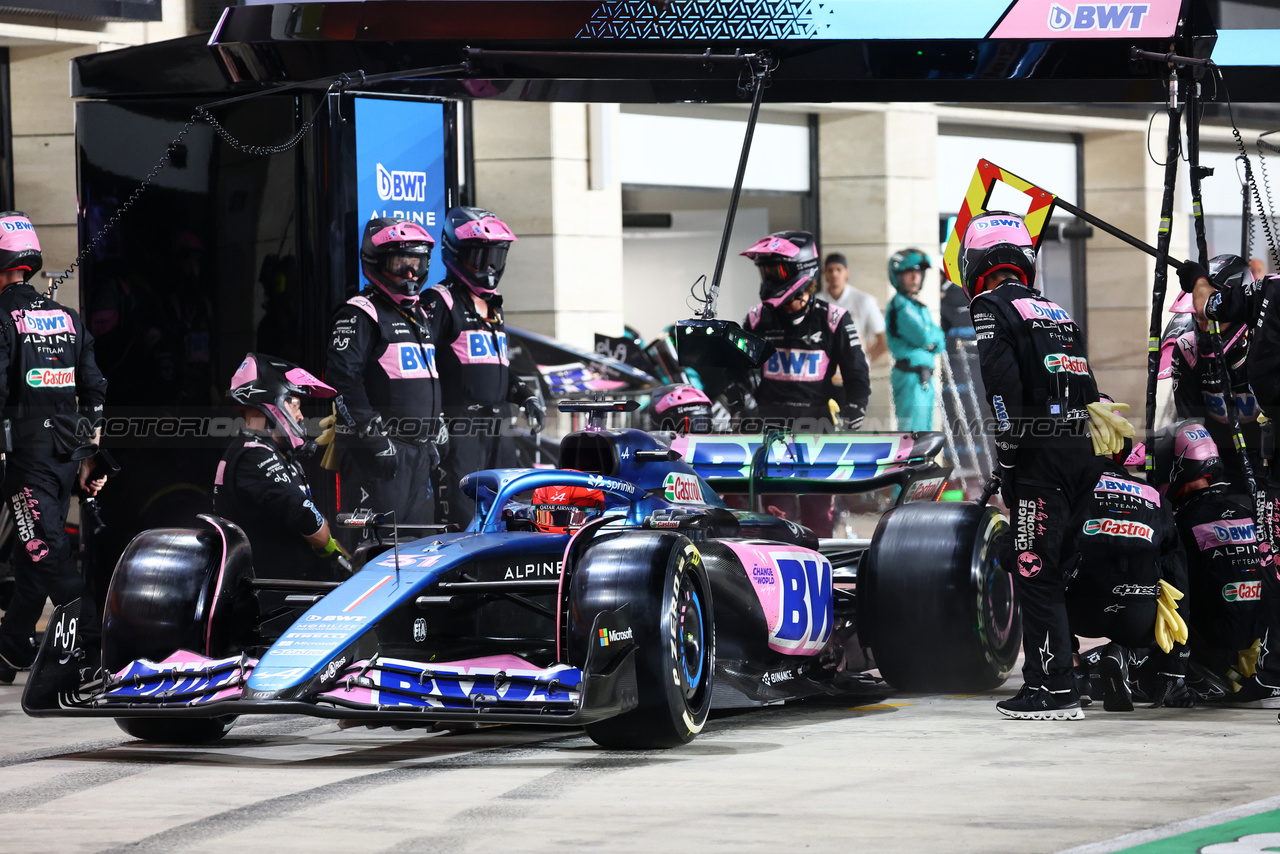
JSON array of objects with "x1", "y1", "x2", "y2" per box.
[{"x1": 858, "y1": 502, "x2": 1021, "y2": 693}]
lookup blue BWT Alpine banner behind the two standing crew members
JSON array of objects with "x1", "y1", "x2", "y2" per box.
[{"x1": 355, "y1": 96, "x2": 447, "y2": 286}]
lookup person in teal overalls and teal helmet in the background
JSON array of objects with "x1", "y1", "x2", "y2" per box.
[{"x1": 884, "y1": 248, "x2": 947, "y2": 430}]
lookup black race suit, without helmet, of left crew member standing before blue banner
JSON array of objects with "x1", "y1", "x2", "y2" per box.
[{"x1": 325, "y1": 286, "x2": 440, "y2": 525}]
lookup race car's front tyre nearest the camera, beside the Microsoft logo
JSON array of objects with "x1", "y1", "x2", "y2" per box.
[{"x1": 572, "y1": 533, "x2": 716, "y2": 750}]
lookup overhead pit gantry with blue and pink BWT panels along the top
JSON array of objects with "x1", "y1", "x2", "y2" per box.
[{"x1": 73, "y1": 0, "x2": 1276, "y2": 104}]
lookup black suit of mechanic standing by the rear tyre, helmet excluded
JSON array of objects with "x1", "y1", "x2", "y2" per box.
[{"x1": 970, "y1": 282, "x2": 1101, "y2": 695}]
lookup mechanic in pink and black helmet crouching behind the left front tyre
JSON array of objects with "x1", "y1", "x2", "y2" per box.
[{"x1": 214, "y1": 353, "x2": 351, "y2": 581}]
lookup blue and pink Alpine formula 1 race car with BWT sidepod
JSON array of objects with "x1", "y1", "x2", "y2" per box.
[{"x1": 23, "y1": 402, "x2": 1020, "y2": 748}]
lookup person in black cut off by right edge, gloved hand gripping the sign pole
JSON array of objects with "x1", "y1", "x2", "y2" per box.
[{"x1": 1178, "y1": 262, "x2": 1280, "y2": 703}]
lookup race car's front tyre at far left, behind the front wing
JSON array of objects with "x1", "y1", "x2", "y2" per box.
[{"x1": 102, "y1": 517, "x2": 256, "y2": 744}]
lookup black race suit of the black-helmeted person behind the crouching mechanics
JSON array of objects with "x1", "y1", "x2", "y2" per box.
[{"x1": 1172, "y1": 324, "x2": 1262, "y2": 495}]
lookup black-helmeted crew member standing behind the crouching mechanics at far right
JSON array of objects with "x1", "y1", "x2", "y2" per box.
[{"x1": 1170, "y1": 255, "x2": 1262, "y2": 495}]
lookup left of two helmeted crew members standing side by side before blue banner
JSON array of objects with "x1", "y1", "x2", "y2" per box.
[{"x1": 325, "y1": 216, "x2": 440, "y2": 525}]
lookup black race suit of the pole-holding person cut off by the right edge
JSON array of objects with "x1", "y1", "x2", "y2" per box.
[{"x1": 1204, "y1": 275, "x2": 1280, "y2": 688}]
